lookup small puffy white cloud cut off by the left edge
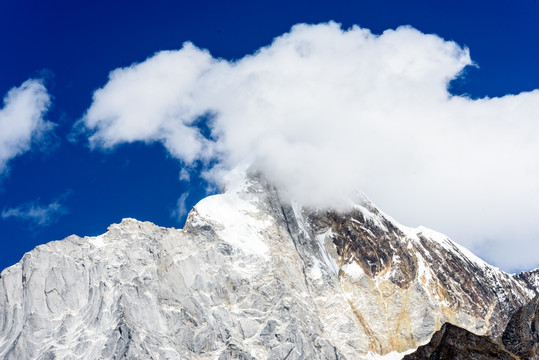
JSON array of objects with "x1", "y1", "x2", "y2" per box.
[{"x1": 0, "y1": 79, "x2": 52, "y2": 174}]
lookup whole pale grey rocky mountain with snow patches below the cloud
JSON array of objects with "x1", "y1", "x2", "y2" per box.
[{"x1": 0, "y1": 178, "x2": 539, "y2": 360}]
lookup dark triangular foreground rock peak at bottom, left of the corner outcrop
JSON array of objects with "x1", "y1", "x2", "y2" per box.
[{"x1": 403, "y1": 323, "x2": 517, "y2": 360}]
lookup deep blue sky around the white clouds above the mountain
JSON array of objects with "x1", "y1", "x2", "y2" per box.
[{"x1": 0, "y1": 0, "x2": 539, "y2": 271}]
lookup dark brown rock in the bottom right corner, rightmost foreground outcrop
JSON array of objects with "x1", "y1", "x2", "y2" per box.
[{"x1": 502, "y1": 296, "x2": 539, "y2": 360}]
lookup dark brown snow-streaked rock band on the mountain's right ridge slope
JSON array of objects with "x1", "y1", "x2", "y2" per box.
[{"x1": 303, "y1": 201, "x2": 539, "y2": 343}]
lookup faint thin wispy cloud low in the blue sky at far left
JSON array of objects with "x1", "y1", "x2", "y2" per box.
[{"x1": 2, "y1": 192, "x2": 70, "y2": 227}]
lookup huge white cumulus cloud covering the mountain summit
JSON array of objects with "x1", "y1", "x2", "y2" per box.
[{"x1": 82, "y1": 22, "x2": 539, "y2": 269}]
